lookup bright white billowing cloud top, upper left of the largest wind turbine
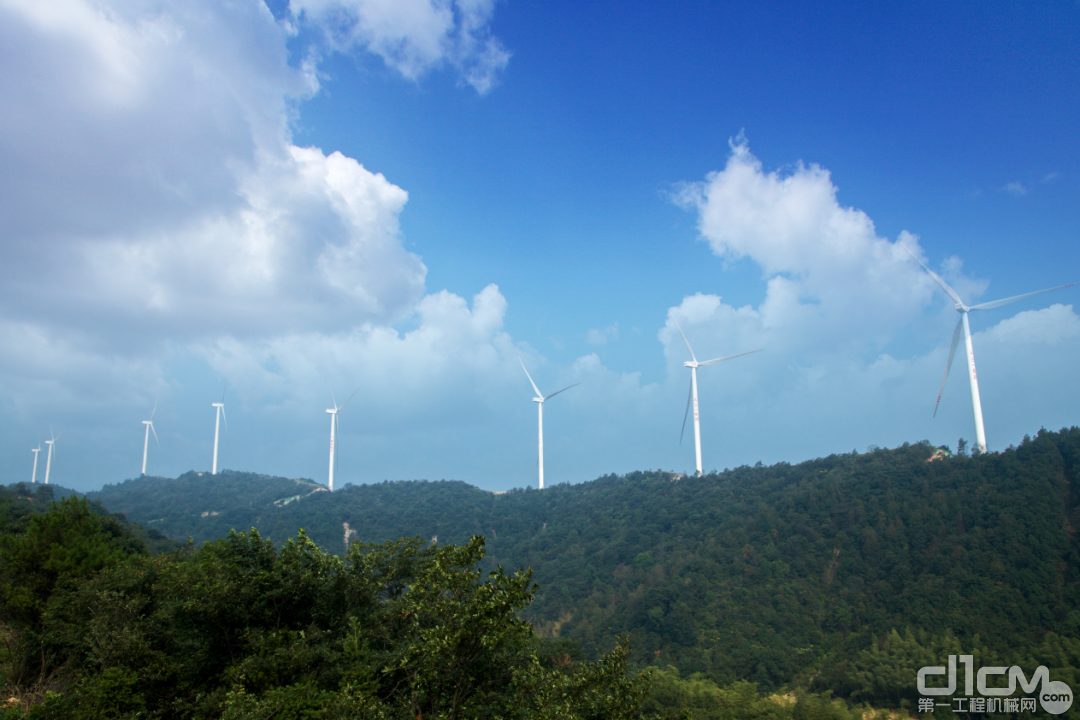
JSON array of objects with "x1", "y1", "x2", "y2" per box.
[{"x1": 665, "y1": 136, "x2": 959, "y2": 353}]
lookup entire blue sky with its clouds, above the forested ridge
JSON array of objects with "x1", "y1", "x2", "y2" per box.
[{"x1": 0, "y1": 0, "x2": 1080, "y2": 490}]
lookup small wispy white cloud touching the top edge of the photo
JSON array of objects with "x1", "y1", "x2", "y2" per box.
[{"x1": 289, "y1": 0, "x2": 510, "y2": 95}]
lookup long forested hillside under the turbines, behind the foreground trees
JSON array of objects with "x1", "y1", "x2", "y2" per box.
[{"x1": 84, "y1": 427, "x2": 1080, "y2": 703}]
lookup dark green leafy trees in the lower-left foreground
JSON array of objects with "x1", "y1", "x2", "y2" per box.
[{"x1": 2, "y1": 526, "x2": 647, "y2": 719}]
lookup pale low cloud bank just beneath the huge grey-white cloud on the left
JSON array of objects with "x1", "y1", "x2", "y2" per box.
[{"x1": 200, "y1": 285, "x2": 522, "y2": 430}]
